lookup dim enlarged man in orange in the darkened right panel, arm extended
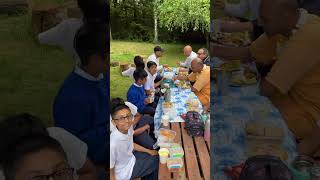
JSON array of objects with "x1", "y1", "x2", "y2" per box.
[{"x1": 210, "y1": 0, "x2": 320, "y2": 156}]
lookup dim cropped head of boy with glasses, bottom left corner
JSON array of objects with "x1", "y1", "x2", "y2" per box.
[{"x1": 3, "y1": 134, "x2": 75, "y2": 180}]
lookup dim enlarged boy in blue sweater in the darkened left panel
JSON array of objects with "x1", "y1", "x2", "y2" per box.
[{"x1": 53, "y1": 24, "x2": 110, "y2": 167}]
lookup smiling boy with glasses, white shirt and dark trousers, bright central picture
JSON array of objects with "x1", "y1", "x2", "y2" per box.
[{"x1": 110, "y1": 100, "x2": 159, "y2": 180}]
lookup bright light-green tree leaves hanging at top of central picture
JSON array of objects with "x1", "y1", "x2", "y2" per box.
[{"x1": 157, "y1": 0, "x2": 210, "y2": 32}]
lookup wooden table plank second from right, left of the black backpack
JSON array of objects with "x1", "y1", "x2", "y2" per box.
[{"x1": 181, "y1": 123, "x2": 202, "y2": 180}]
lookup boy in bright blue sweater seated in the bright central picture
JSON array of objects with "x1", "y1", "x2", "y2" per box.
[{"x1": 127, "y1": 69, "x2": 156, "y2": 116}]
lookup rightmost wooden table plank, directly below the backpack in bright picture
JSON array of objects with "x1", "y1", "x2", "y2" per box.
[{"x1": 194, "y1": 137, "x2": 210, "y2": 180}]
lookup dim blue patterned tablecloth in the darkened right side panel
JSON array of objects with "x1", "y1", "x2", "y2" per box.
[{"x1": 211, "y1": 59, "x2": 297, "y2": 180}]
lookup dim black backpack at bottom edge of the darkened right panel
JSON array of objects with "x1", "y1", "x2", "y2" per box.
[{"x1": 239, "y1": 155, "x2": 293, "y2": 180}]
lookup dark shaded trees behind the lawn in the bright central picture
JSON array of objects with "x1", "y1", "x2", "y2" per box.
[{"x1": 110, "y1": 0, "x2": 209, "y2": 43}]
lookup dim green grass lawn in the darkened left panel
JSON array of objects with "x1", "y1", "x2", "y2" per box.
[{"x1": 0, "y1": 15, "x2": 74, "y2": 125}]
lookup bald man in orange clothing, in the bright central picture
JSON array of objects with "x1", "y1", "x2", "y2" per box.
[{"x1": 177, "y1": 58, "x2": 210, "y2": 111}]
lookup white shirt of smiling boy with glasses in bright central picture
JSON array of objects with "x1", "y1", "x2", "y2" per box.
[{"x1": 110, "y1": 126, "x2": 136, "y2": 180}]
